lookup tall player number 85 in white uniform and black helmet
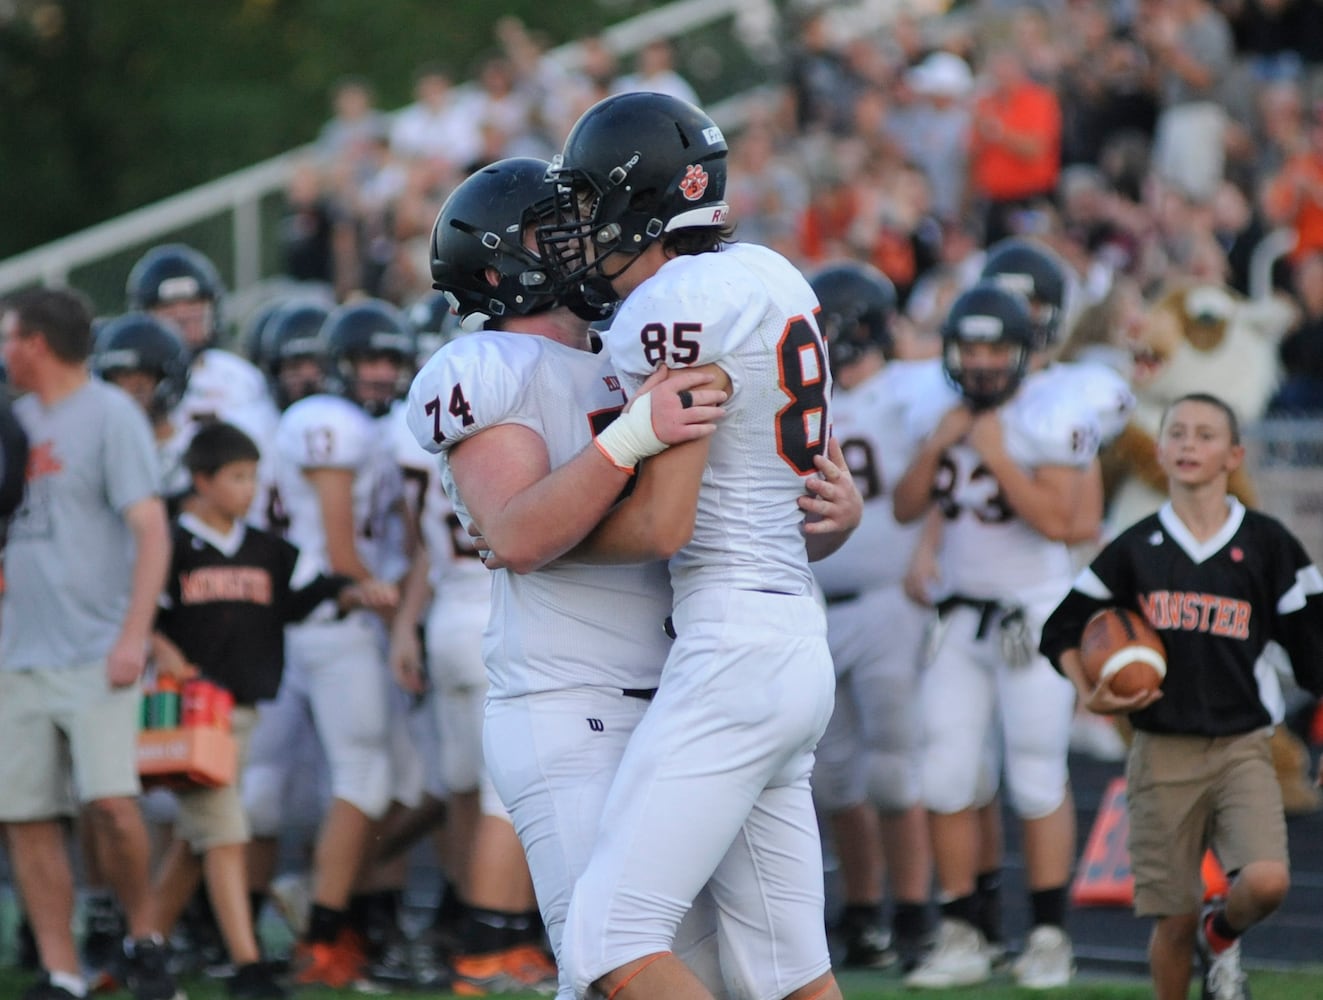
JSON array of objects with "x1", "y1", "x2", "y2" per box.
[{"x1": 540, "y1": 94, "x2": 840, "y2": 1000}]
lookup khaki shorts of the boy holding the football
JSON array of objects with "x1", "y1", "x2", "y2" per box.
[{"x1": 1126, "y1": 730, "x2": 1287, "y2": 917}]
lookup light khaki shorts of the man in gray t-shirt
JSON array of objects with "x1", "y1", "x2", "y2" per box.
[{"x1": 0, "y1": 661, "x2": 142, "y2": 823}]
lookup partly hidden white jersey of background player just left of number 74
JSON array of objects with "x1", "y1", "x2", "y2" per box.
[{"x1": 388, "y1": 402, "x2": 492, "y2": 606}]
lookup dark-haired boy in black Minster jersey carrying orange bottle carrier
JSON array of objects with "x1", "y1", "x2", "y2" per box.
[{"x1": 153, "y1": 423, "x2": 394, "y2": 997}]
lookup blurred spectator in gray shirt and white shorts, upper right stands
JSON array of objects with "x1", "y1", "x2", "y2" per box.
[{"x1": 1136, "y1": 0, "x2": 1232, "y2": 201}]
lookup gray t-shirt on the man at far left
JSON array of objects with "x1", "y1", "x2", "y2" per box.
[{"x1": 0, "y1": 378, "x2": 160, "y2": 671}]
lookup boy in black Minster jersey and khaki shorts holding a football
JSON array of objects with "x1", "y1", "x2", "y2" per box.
[{"x1": 1040, "y1": 393, "x2": 1323, "y2": 1000}]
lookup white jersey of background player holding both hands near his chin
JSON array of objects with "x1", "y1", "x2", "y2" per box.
[{"x1": 926, "y1": 384, "x2": 1101, "y2": 604}]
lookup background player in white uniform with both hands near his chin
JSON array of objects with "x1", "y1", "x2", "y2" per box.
[{"x1": 894, "y1": 280, "x2": 1101, "y2": 988}]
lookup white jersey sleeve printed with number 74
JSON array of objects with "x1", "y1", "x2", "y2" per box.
[{"x1": 407, "y1": 332, "x2": 542, "y2": 452}]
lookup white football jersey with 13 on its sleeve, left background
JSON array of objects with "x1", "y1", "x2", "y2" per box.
[{"x1": 275, "y1": 396, "x2": 404, "y2": 579}]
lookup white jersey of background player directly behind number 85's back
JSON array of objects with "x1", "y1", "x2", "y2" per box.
[{"x1": 812, "y1": 361, "x2": 930, "y2": 597}]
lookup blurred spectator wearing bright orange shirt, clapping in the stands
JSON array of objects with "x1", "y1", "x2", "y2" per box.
[{"x1": 970, "y1": 46, "x2": 1061, "y2": 243}]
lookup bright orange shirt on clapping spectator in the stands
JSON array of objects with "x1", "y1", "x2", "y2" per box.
[{"x1": 970, "y1": 82, "x2": 1061, "y2": 201}]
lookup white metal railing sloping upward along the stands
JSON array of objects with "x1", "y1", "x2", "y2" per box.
[{"x1": 0, "y1": 0, "x2": 778, "y2": 295}]
